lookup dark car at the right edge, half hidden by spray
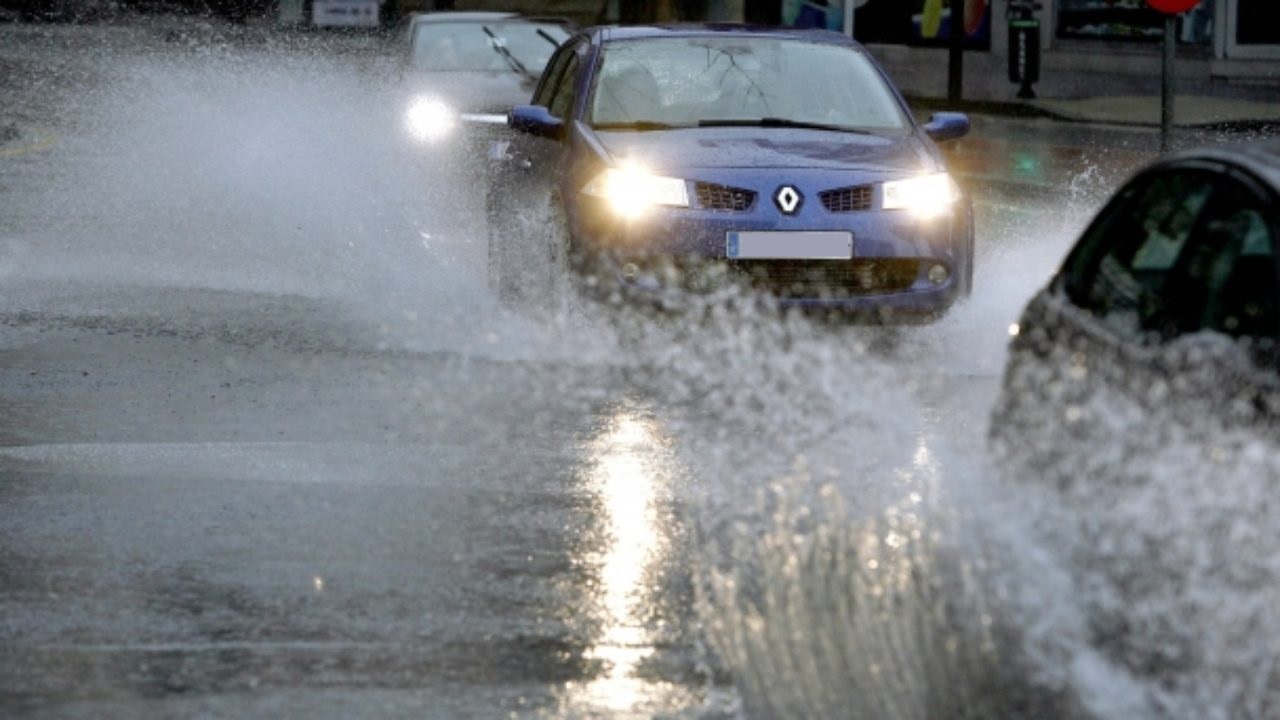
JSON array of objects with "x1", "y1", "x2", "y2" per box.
[{"x1": 992, "y1": 141, "x2": 1280, "y2": 476}]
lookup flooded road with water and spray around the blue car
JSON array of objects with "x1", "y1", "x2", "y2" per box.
[{"x1": 0, "y1": 19, "x2": 1259, "y2": 717}]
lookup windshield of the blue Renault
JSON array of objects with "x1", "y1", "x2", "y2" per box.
[{"x1": 588, "y1": 37, "x2": 908, "y2": 131}]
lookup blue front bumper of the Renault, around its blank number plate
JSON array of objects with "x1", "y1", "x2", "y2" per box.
[{"x1": 571, "y1": 190, "x2": 973, "y2": 315}]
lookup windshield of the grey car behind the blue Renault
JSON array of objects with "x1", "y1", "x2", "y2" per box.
[{"x1": 411, "y1": 22, "x2": 568, "y2": 74}]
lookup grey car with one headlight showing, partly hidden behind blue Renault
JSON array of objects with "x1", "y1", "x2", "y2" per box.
[{"x1": 404, "y1": 12, "x2": 572, "y2": 150}]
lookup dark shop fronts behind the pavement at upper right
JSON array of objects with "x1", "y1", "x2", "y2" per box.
[{"x1": 744, "y1": 0, "x2": 1280, "y2": 101}]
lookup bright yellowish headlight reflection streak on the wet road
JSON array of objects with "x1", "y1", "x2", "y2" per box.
[{"x1": 564, "y1": 406, "x2": 678, "y2": 716}]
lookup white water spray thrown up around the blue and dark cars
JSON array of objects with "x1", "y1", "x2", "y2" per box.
[{"x1": 0, "y1": 20, "x2": 1280, "y2": 717}]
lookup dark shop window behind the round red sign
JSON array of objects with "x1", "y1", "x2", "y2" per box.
[{"x1": 1057, "y1": 0, "x2": 1213, "y2": 45}]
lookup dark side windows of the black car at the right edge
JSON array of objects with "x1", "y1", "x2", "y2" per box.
[{"x1": 1065, "y1": 169, "x2": 1276, "y2": 351}]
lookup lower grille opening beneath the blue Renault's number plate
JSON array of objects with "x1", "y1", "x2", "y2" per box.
[{"x1": 733, "y1": 258, "x2": 920, "y2": 300}]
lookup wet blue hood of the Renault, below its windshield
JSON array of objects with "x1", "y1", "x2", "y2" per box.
[{"x1": 595, "y1": 127, "x2": 941, "y2": 172}]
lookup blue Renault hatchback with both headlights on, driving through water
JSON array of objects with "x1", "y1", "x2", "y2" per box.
[{"x1": 488, "y1": 26, "x2": 974, "y2": 316}]
